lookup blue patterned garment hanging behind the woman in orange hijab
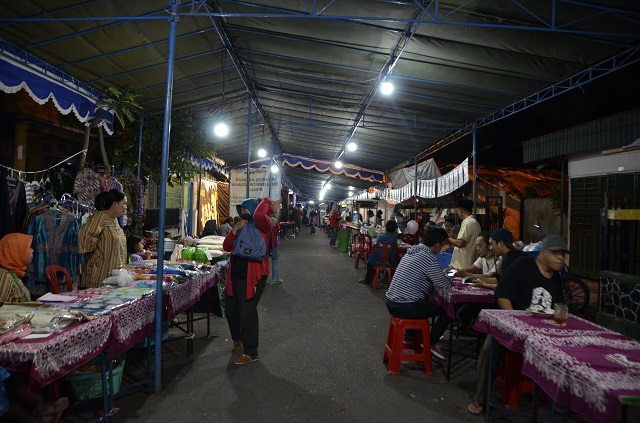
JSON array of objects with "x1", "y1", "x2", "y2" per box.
[{"x1": 27, "y1": 209, "x2": 81, "y2": 298}]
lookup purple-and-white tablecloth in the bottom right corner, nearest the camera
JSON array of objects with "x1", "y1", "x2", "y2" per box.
[{"x1": 522, "y1": 333, "x2": 640, "y2": 423}]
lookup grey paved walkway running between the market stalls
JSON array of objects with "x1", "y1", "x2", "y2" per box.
[{"x1": 63, "y1": 228, "x2": 596, "y2": 423}]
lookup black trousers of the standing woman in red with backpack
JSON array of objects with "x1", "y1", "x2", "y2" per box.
[{"x1": 225, "y1": 275, "x2": 267, "y2": 356}]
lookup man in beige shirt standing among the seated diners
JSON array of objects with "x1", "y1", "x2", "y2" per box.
[{"x1": 449, "y1": 200, "x2": 482, "y2": 269}]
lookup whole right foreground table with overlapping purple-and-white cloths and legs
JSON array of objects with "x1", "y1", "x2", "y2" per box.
[{"x1": 475, "y1": 310, "x2": 640, "y2": 422}]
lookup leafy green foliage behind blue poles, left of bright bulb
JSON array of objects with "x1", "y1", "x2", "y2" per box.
[{"x1": 114, "y1": 109, "x2": 215, "y2": 186}]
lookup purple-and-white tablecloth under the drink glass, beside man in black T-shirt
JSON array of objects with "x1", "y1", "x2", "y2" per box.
[{"x1": 474, "y1": 309, "x2": 615, "y2": 353}]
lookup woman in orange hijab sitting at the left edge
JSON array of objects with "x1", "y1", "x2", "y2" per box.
[{"x1": 0, "y1": 233, "x2": 33, "y2": 303}]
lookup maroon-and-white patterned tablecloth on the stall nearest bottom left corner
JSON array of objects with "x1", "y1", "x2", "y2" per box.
[{"x1": 0, "y1": 316, "x2": 111, "y2": 394}]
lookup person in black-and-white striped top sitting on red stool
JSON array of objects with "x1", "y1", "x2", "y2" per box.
[{"x1": 386, "y1": 227, "x2": 451, "y2": 360}]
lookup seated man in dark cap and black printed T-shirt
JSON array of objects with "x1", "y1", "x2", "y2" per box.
[{"x1": 467, "y1": 233, "x2": 569, "y2": 415}]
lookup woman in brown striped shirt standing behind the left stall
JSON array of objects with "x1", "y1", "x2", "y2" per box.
[{"x1": 78, "y1": 189, "x2": 127, "y2": 288}]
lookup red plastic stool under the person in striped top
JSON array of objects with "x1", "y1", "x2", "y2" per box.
[{"x1": 382, "y1": 316, "x2": 433, "y2": 375}]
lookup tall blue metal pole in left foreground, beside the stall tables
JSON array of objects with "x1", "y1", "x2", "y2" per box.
[{"x1": 154, "y1": 0, "x2": 178, "y2": 393}]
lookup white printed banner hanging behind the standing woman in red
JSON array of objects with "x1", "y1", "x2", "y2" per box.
[{"x1": 229, "y1": 167, "x2": 282, "y2": 212}]
